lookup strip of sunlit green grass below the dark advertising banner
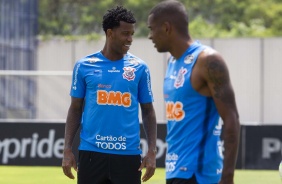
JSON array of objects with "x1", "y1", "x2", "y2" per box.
[{"x1": 0, "y1": 166, "x2": 282, "y2": 184}]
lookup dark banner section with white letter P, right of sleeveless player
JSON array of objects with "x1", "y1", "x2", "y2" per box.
[{"x1": 241, "y1": 125, "x2": 282, "y2": 170}]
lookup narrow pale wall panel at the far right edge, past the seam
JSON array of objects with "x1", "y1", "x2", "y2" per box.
[{"x1": 263, "y1": 38, "x2": 282, "y2": 124}]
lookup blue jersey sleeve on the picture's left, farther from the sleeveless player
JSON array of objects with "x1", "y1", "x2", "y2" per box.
[{"x1": 70, "y1": 62, "x2": 86, "y2": 98}]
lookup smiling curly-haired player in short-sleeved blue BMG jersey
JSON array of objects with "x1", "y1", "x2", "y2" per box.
[{"x1": 62, "y1": 6, "x2": 156, "y2": 184}]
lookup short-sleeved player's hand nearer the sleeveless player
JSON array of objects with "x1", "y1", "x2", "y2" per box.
[{"x1": 139, "y1": 151, "x2": 156, "y2": 182}]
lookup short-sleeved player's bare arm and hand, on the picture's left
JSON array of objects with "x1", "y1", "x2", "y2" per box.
[{"x1": 62, "y1": 97, "x2": 83, "y2": 179}]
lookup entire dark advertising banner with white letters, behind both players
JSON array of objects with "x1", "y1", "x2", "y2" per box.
[{"x1": 0, "y1": 122, "x2": 282, "y2": 170}]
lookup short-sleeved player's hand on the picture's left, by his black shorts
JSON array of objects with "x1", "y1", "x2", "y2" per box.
[{"x1": 62, "y1": 149, "x2": 77, "y2": 179}]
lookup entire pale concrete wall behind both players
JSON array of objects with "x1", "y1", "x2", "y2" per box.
[{"x1": 37, "y1": 38, "x2": 282, "y2": 124}]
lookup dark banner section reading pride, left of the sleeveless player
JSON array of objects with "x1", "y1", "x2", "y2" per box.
[{"x1": 0, "y1": 122, "x2": 166, "y2": 167}]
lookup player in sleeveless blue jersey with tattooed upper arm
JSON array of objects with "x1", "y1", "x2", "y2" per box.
[{"x1": 148, "y1": 0, "x2": 240, "y2": 184}]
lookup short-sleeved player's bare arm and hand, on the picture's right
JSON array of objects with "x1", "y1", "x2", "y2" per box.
[{"x1": 139, "y1": 103, "x2": 157, "y2": 182}]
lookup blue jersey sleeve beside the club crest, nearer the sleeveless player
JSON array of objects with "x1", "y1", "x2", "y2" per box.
[{"x1": 138, "y1": 65, "x2": 154, "y2": 103}]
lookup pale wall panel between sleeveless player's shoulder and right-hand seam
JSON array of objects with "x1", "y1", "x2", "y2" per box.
[{"x1": 214, "y1": 39, "x2": 261, "y2": 122}]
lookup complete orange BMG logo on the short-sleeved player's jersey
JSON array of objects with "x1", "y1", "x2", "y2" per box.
[{"x1": 97, "y1": 90, "x2": 131, "y2": 107}]
